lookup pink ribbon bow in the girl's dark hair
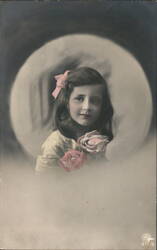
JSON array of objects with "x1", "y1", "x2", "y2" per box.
[{"x1": 52, "y1": 70, "x2": 70, "y2": 98}]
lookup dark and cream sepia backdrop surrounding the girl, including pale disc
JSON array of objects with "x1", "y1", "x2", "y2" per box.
[{"x1": 0, "y1": 1, "x2": 157, "y2": 249}]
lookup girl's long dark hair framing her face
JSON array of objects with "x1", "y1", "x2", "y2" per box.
[{"x1": 53, "y1": 67, "x2": 113, "y2": 140}]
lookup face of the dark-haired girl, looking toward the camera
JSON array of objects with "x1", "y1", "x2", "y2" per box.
[{"x1": 69, "y1": 84, "x2": 103, "y2": 126}]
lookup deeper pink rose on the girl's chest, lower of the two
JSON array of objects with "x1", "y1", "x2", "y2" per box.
[{"x1": 59, "y1": 150, "x2": 87, "y2": 172}]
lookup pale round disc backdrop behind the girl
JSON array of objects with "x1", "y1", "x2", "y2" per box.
[{"x1": 10, "y1": 34, "x2": 152, "y2": 160}]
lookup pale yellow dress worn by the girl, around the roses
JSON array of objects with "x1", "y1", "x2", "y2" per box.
[{"x1": 36, "y1": 130, "x2": 106, "y2": 172}]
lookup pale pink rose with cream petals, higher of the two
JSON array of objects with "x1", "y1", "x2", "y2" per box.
[{"x1": 77, "y1": 130, "x2": 109, "y2": 153}]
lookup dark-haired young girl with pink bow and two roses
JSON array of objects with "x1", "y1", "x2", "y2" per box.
[{"x1": 36, "y1": 67, "x2": 113, "y2": 171}]
